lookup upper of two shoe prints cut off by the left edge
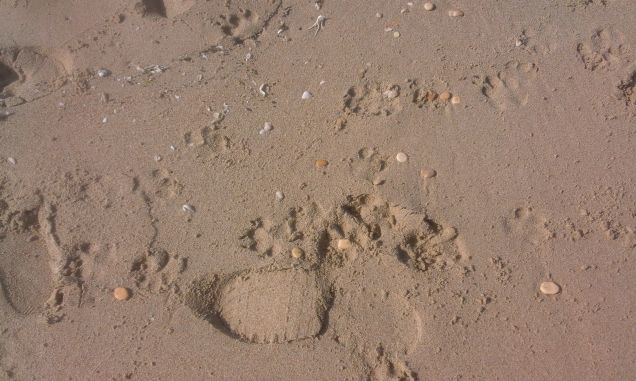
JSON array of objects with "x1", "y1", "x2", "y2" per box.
[{"x1": 0, "y1": 47, "x2": 67, "y2": 106}]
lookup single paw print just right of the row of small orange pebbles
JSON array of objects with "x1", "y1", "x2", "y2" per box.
[{"x1": 481, "y1": 61, "x2": 538, "y2": 110}]
